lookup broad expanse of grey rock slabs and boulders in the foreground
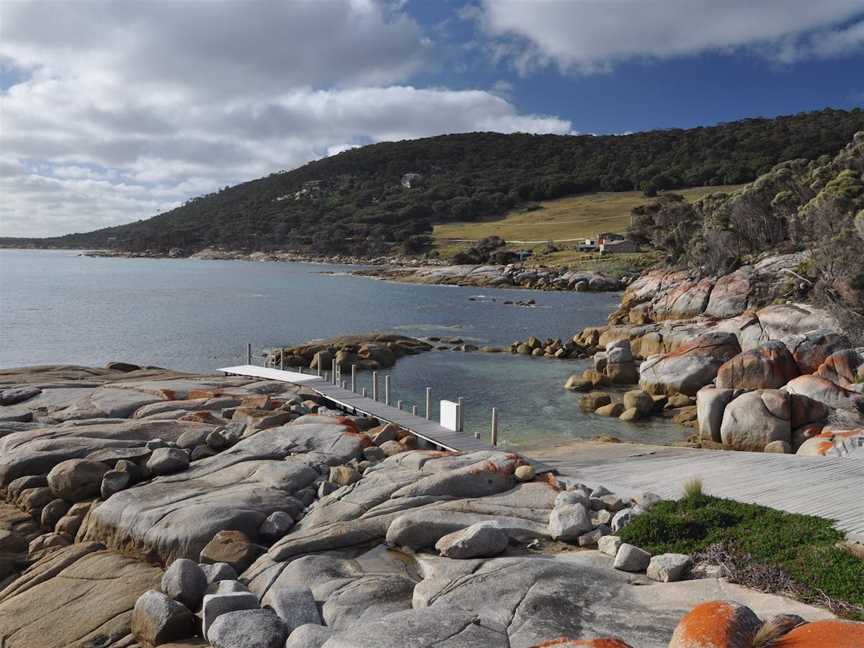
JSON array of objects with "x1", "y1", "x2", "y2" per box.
[{"x1": 0, "y1": 363, "x2": 864, "y2": 648}]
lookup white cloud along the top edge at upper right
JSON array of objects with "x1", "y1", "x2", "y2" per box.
[{"x1": 477, "y1": 0, "x2": 864, "y2": 74}]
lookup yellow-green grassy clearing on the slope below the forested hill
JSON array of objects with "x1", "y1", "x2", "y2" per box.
[{"x1": 433, "y1": 186, "x2": 737, "y2": 249}]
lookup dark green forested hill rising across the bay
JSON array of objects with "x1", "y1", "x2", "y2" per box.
[{"x1": 10, "y1": 108, "x2": 864, "y2": 255}]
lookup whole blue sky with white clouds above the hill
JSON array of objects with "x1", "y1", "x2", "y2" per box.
[{"x1": 0, "y1": 0, "x2": 864, "y2": 236}]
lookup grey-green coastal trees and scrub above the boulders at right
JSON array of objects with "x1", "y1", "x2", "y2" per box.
[{"x1": 629, "y1": 131, "x2": 864, "y2": 342}]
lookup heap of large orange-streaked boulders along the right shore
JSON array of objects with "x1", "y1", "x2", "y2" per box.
[{"x1": 565, "y1": 254, "x2": 864, "y2": 456}]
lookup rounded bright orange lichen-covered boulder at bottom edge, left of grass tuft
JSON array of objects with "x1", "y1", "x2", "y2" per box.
[{"x1": 669, "y1": 601, "x2": 762, "y2": 648}]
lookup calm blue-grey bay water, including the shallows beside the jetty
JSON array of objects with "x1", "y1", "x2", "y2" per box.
[{"x1": 0, "y1": 250, "x2": 684, "y2": 445}]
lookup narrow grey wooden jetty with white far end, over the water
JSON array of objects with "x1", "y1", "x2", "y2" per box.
[{"x1": 219, "y1": 365, "x2": 552, "y2": 473}]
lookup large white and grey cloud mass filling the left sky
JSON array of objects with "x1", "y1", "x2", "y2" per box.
[{"x1": 0, "y1": 0, "x2": 571, "y2": 236}]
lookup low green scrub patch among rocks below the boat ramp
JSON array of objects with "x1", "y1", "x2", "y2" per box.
[{"x1": 620, "y1": 488, "x2": 864, "y2": 621}]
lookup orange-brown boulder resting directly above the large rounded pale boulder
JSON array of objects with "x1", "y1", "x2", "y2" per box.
[{"x1": 717, "y1": 340, "x2": 800, "y2": 390}]
